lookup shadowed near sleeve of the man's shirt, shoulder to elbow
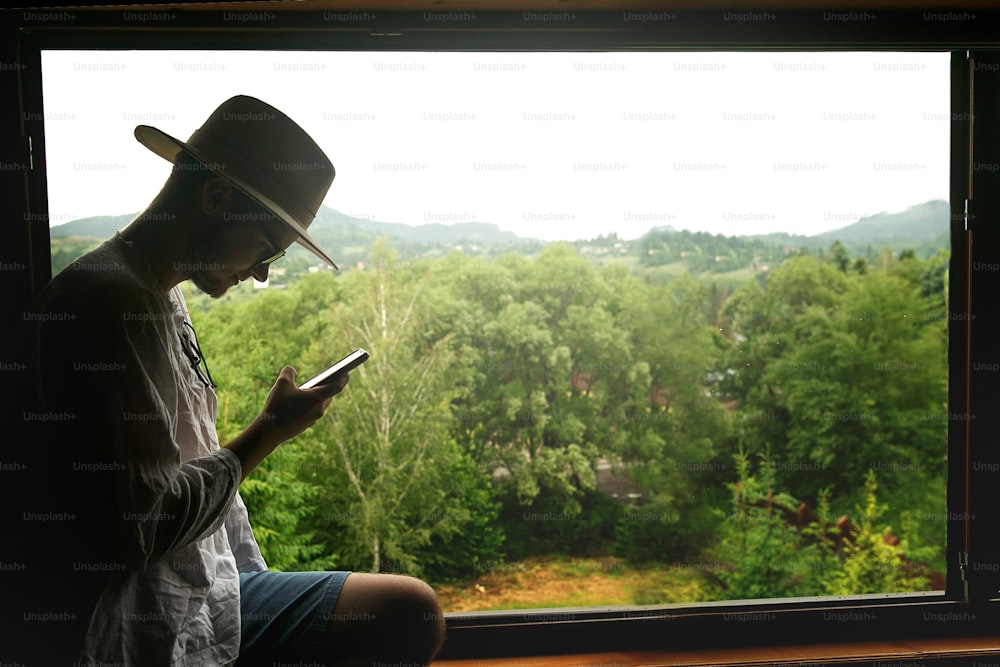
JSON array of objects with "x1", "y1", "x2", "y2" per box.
[{"x1": 41, "y1": 276, "x2": 241, "y2": 570}]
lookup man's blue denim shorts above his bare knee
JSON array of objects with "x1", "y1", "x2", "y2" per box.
[{"x1": 236, "y1": 571, "x2": 350, "y2": 667}]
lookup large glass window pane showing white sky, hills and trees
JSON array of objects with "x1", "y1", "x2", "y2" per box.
[{"x1": 43, "y1": 51, "x2": 944, "y2": 611}]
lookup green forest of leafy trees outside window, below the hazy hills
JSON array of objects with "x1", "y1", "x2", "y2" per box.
[{"x1": 174, "y1": 239, "x2": 950, "y2": 611}]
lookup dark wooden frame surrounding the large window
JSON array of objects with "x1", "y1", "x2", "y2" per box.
[{"x1": 0, "y1": 6, "x2": 1000, "y2": 659}]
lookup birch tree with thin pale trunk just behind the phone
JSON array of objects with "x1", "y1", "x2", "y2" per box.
[{"x1": 298, "y1": 242, "x2": 499, "y2": 574}]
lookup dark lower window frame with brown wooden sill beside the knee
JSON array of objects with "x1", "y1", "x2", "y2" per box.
[{"x1": 435, "y1": 593, "x2": 1000, "y2": 667}]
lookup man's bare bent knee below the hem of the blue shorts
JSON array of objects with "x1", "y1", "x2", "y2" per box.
[{"x1": 327, "y1": 572, "x2": 444, "y2": 667}]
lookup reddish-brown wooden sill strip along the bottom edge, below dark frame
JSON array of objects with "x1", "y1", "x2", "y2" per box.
[{"x1": 434, "y1": 635, "x2": 1000, "y2": 667}]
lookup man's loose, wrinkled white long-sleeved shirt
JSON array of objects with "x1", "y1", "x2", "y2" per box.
[{"x1": 27, "y1": 237, "x2": 267, "y2": 667}]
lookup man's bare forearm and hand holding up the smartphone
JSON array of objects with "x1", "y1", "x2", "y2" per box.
[{"x1": 226, "y1": 366, "x2": 349, "y2": 479}]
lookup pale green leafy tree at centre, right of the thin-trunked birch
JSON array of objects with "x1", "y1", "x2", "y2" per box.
[{"x1": 448, "y1": 245, "x2": 608, "y2": 514}]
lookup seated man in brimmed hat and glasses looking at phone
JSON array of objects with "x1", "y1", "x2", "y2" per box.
[{"x1": 9, "y1": 96, "x2": 443, "y2": 667}]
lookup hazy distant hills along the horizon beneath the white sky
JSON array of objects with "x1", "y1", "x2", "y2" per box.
[{"x1": 51, "y1": 201, "x2": 950, "y2": 275}]
